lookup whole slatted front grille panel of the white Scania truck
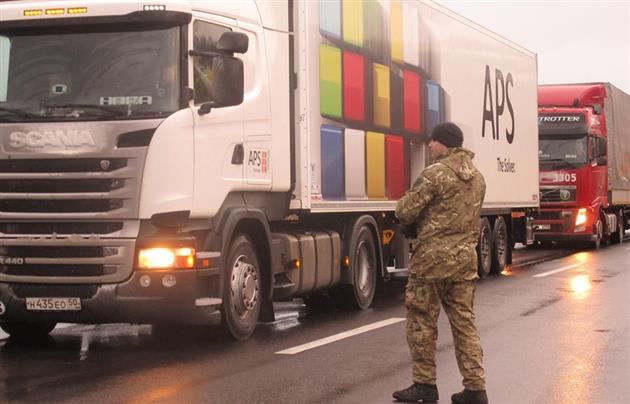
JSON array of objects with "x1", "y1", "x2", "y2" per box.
[{"x1": 0, "y1": 120, "x2": 155, "y2": 282}]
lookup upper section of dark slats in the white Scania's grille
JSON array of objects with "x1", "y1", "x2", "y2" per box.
[{"x1": 0, "y1": 155, "x2": 143, "y2": 218}]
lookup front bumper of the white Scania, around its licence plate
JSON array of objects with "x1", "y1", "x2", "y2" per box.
[{"x1": 0, "y1": 268, "x2": 221, "y2": 324}]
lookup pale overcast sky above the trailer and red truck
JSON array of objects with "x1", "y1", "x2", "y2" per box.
[{"x1": 437, "y1": 0, "x2": 630, "y2": 94}]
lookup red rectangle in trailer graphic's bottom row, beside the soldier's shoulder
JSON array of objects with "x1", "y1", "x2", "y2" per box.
[{"x1": 385, "y1": 135, "x2": 409, "y2": 200}]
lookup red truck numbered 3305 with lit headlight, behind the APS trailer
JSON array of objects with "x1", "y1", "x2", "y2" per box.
[{"x1": 534, "y1": 83, "x2": 630, "y2": 248}]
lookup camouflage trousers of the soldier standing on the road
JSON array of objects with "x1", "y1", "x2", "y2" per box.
[{"x1": 405, "y1": 277, "x2": 486, "y2": 390}]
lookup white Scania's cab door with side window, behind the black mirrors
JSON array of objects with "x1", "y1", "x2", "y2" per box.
[{"x1": 189, "y1": 14, "x2": 244, "y2": 217}]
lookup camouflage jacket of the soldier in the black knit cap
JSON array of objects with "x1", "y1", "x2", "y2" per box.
[{"x1": 396, "y1": 147, "x2": 486, "y2": 280}]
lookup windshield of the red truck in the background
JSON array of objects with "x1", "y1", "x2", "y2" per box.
[{"x1": 538, "y1": 134, "x2": 588, "y2": 170}]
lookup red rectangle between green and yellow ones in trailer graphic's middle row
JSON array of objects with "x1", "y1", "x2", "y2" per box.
[{"x1": 343, "y1": 51, "x2": 365, "y2": 122}]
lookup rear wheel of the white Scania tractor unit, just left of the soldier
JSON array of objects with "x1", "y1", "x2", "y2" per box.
[{"x1": 337, "y1": 225, "x2": 378, "y2": 310}]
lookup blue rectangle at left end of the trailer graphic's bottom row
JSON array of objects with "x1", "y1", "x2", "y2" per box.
[{"x1": 321, "y1": 125, "x2": 345, "y2": 199}]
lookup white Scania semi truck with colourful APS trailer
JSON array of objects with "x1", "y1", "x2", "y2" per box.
[{"x1": 0, "y1": 0, "x2": 538, "y2": 339}]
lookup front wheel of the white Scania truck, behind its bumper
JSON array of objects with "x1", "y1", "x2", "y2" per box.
[{"x1": 221, "y1": 234, "x2": 263, "y2": 341}]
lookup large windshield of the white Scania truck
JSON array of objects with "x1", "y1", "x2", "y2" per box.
[{"x1": 0, "y1": 26, "x2": 181, "y2": 122}]
